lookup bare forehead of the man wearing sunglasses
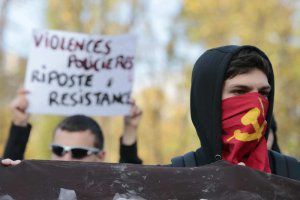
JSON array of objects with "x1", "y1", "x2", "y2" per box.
[{"x1": 53, "y1": 129, "x2": 96, "y2": 147}]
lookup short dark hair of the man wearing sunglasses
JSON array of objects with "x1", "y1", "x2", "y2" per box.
[{"x1": 55, "y1": 115, "x2": 104, "y2": 149}]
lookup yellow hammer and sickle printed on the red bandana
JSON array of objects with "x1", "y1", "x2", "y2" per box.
[{"x1": 227, "y1": 99, "x2": 267, "y2": 142}]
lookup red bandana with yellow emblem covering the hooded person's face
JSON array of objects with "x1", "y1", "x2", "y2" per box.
[{"x1": 222, "y1": 92, "x2": 271, "y2": 173}]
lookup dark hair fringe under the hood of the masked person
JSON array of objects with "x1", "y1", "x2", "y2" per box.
[{"x1": 225, "y1": 48, "x2": 271, "y2": 80}]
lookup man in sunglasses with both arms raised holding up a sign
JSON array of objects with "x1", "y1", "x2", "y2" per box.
[{"x1": 3, "y1": 89, "x2": 142, "y2": 164}]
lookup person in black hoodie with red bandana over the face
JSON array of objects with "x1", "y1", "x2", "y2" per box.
[{"x1": 171, "y1": 45, "x2": 300, "y2": 180}]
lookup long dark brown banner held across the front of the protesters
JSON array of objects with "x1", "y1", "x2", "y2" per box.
[{"x1": 0, "y1": 161, "x2": 300, "y2": 200}]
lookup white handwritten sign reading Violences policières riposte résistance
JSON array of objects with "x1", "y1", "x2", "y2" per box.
[{"x1": 25, "y1": 30, "x2": 136, "y2": 116}]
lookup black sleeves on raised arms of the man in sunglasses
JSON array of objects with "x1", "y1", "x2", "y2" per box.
[{"x1": 3, "y1": 124, "x2": 142, "y2": 164}]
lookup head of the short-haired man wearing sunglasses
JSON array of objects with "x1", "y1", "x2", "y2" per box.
[{"x1": 50, "y1": 115, "x2": 105, "y2": 162}]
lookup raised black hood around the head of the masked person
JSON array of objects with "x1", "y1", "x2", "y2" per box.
[{"x1": 190, "y1": 45, "x2": 274, "y2": 163}]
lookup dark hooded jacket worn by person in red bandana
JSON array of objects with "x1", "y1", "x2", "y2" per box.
[{"x1": 172, "y1": 45, "x2": 300, "y2": 180}]
